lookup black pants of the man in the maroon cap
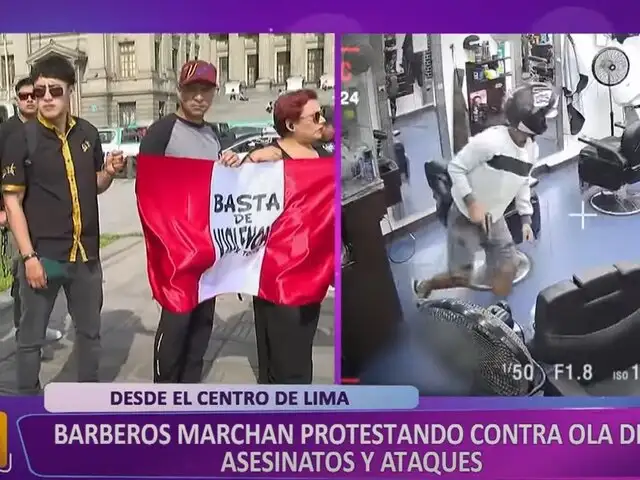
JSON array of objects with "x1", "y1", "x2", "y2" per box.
[{"x1": 153, "y1": 298, "x2": 216, "y2": 383}]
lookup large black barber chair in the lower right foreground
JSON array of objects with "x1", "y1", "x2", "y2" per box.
[{"x1": 528, "y1": 264, "x2": 640, "y2": 396}]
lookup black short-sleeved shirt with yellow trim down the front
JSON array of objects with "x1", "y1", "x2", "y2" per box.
[{"x1": 2, "y1": 117, "x2": 104, "y2": 262}]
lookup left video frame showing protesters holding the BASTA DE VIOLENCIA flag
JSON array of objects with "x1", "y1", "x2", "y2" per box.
[{"x1": 0, "y1": 33, "x2": 335, "y2": 395}]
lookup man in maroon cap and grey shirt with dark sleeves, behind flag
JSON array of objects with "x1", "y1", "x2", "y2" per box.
[{"x1": 140, "y1": 60, "x2": 238, "y2": 383}]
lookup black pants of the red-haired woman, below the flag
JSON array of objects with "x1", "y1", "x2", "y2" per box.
[{"x1": 253, "y1": 297, "x2": 320, "y2": 385}]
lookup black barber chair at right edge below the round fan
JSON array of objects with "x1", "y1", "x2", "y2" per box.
[{"x1": 578, "y1": 121, "x2": 640, "y2": 216}]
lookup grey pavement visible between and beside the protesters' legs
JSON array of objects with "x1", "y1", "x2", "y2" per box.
[{"x1": 0, "y1": 240, "x2": 334, "y2": 394}]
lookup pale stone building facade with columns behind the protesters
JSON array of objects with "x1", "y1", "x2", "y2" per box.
[{"x1": 0, "y1": 33, "x2": 335, "y2": 126}]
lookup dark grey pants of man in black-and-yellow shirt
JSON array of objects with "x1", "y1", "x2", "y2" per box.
[{"x1": 16, "y1": 261, "x2": 102, "y2": 395}]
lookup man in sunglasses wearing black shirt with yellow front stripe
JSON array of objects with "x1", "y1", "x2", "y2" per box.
[{"x1": 2, "y1": 56, "x2": 125, "y2": 395}]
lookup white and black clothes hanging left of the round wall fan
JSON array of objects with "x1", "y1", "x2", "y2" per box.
[{"x1": 562, "y1": 34, "x2": 589, "y2": 135}]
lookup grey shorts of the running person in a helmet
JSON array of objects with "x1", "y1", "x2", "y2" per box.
[{"x1": 447, "y1": 204, "x2": 517, "y2": 275}]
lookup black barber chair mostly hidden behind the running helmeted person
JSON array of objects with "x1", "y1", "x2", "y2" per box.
[{"x1": 424, "y1": 161, "x2": 541, "y2": 290}]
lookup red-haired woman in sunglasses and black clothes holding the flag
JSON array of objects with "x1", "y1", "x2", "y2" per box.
[{"x1": 219, "y1": 89, "x2": 333, "y2": 384}]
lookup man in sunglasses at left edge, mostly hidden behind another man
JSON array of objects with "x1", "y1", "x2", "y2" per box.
[{"x1": 0, "y1": 77, "x2": 62, "y2": 343}]
